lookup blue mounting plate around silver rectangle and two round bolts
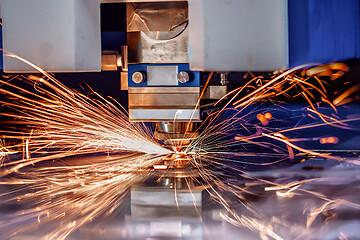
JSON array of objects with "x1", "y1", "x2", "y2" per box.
[{"x1": 128, "y1": 64, "x2": 200, "y2": 87}]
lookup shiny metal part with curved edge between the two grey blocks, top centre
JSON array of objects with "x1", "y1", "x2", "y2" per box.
[{"x1": 127, "y1": 1, "x2": 188, "y2": 63}]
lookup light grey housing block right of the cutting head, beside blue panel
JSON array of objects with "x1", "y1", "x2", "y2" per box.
[{"x1": 188, "y1": 0, "x2": 288, "y2": 72}]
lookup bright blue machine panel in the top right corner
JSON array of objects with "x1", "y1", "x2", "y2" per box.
[{"x1": 288, "y1": 0, "x2": 360, "y2": 67}]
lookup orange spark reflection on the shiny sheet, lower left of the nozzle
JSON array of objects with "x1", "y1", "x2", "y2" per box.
[{"x1": 0, "y1": 154, "x2": 165, "y2": 239}]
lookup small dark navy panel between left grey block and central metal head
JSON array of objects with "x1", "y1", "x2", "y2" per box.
[{"x1": 101, "y1": 32, "x2": 127, "y2": 52}]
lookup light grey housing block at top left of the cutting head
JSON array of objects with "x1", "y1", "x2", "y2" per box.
[{"x1": 1, "y1": 0, "x2": 101, "y2": 72}]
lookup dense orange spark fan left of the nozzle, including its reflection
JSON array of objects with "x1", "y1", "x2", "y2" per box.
[{"x1": 0, "y1": 55, "x2": 171, "y2": 239}]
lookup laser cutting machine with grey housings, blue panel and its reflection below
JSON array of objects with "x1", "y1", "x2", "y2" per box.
[{"x1": 0, "y1": 0, "x2": 360, "y2": 239}]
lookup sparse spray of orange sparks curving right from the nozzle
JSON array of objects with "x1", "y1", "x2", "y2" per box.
[{"x1": 185, "y1": 63, "x2": 360, "y2": 239}]
